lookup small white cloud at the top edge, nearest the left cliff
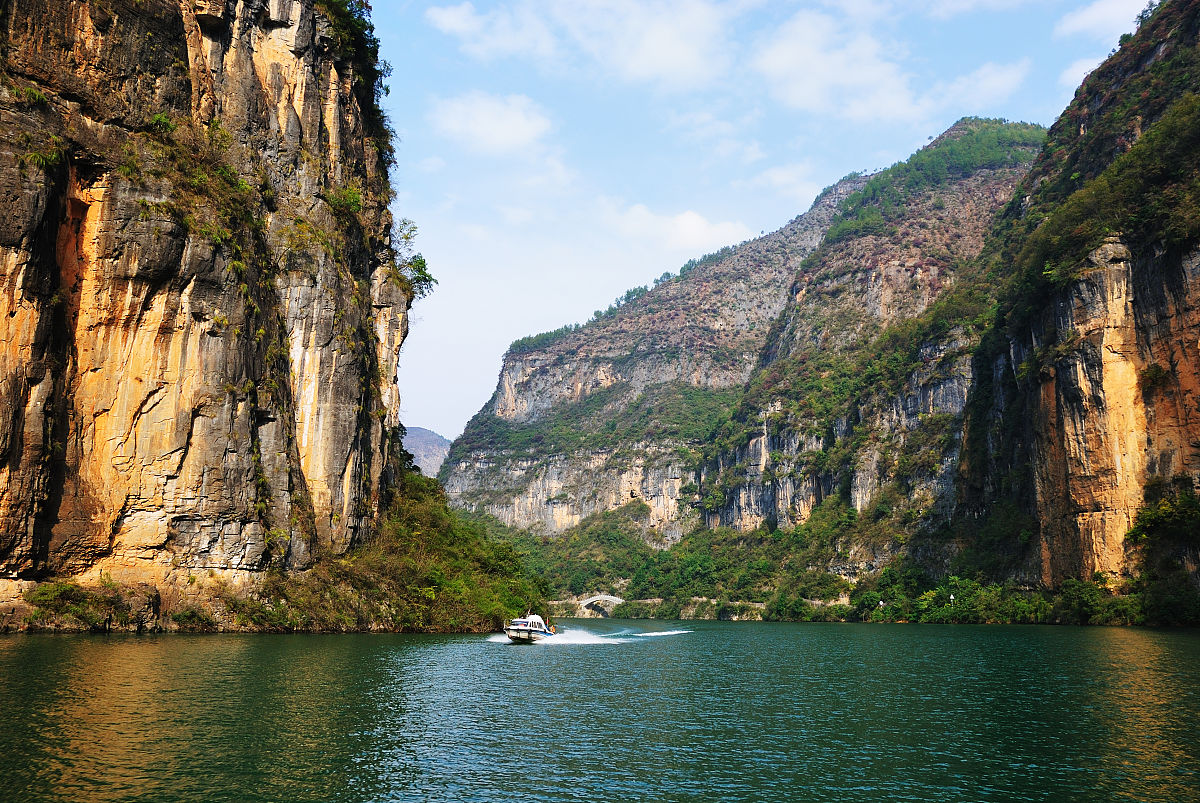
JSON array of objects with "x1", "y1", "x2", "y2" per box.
[{"x1": 425, "y1": 2, "x2": 558, "y2": 59}]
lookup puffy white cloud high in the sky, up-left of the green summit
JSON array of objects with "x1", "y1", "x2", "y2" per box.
[{"x1": 752, "y1": 11, "x2": 926, "y2": 120}]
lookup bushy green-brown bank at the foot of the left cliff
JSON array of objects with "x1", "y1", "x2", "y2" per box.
[{"x1": 0, "y1": 472, "x2": 548, "y2": 633}]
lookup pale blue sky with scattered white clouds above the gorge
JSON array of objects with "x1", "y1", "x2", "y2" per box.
[{"x1": 373, "y1": 0, "x2": 1146, "y2": 438}]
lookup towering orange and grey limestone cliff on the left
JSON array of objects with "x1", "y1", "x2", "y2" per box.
[{"x1": 0, "y1": 0, "x2": 412, "y2": 585}]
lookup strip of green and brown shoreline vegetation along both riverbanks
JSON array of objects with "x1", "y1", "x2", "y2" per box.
[{"x1": 7, "y1": 482, "x2": 1200, "y2": 633}]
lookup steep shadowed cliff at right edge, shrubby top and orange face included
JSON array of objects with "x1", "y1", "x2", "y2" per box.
[{"x1": 959, "y1": 1, "x2": 1200, "y2": 585}]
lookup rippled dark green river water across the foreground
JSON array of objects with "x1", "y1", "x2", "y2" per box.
[{"x1": 0, "y1": 621, "x2": 1200, "y2": 802}]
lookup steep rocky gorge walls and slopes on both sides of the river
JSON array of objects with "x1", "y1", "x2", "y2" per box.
[{"x1": 0, "y1": 0, "x2": 1200, "y2": 630}]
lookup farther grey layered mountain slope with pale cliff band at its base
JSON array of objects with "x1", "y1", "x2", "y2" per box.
[{"x1": 442, "y1": 179, "x2": 864, "y2": 540}]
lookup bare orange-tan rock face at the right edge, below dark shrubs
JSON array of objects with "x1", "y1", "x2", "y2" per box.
[{"x1": 1014, "y1": 236, "x2": 1200, "y2": 582}]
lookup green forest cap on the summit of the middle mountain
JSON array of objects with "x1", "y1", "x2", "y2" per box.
[{"x1": 824, "y1": 118, "x2": 1045, "y2": 242}]
